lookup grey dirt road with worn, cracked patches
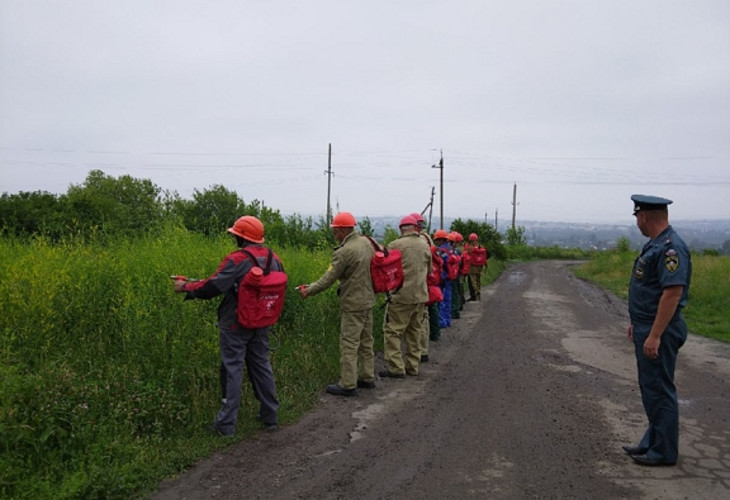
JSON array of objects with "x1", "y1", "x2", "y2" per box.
[{"x1": 153, "y1": 262, "x2": 730, "y2": 500}]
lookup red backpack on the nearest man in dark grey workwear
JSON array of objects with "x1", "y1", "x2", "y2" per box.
[{"x1": 236, "y1": 249, "x2": 287, "y2": 329}]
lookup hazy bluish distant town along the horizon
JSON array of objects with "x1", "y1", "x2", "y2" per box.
[{"x1": 370, "y1": 217, "x2": 730, "y2": 255}]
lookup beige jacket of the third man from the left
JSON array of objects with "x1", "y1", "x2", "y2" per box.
[{"x1": 388, "y1": 233, "x2": 431, "y2": 304}]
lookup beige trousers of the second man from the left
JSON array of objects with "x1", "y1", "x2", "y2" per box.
[{"x1": 339, "y1": 308, "x2": 375, "y2": 389}]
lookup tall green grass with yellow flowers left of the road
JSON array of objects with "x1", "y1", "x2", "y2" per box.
[{"x1": 0, "y1": 228, "x2": 382, "y2": 498}]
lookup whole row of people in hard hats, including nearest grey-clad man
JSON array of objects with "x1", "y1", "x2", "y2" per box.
[{"x1": 174, "y1": 212, "x2": 488, "y2": 436}]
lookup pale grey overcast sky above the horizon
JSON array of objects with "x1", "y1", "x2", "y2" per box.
[{"x1": 0, "y1": 0, "x2": 730, "y2": 223}]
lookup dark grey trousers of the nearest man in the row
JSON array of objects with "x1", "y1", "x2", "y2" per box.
[{"x1": 214, "y1": 327, "x2": 279, "y2": 434}]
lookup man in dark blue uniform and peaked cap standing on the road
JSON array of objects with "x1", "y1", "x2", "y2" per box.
[{"x1": 623, "y1": 195, "x2": 692, "y2": 466}]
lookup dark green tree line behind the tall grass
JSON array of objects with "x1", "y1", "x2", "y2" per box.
[{"x1": 0, "y1": 170, "x2": 504, "y2": 257}]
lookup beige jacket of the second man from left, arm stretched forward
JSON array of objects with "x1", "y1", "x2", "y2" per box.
[{"x1": 309, "y1": 231, "x2": 375, "y2": 311}]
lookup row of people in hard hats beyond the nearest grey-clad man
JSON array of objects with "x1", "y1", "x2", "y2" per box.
[{"x1": 298, "y1": 212, "x2": 488, "y2": 396}]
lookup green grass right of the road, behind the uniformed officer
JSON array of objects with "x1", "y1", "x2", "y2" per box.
[{"x1": 574, "y1": 252, "x2": 730, "y2": 342}]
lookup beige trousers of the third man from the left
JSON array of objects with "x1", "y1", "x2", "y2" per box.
[{"x1": 383, "y1": 303, "x2": 428, "y2": 375}]
